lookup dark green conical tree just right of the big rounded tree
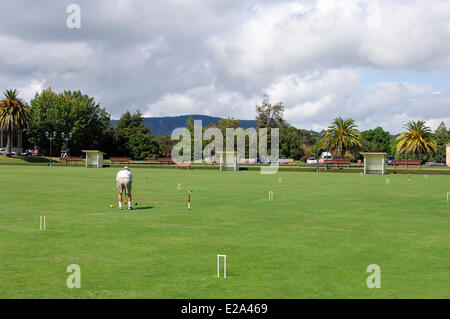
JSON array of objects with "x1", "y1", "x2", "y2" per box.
[{"x1": 114, "y1": 111, "x2": 162, "y2": 160}]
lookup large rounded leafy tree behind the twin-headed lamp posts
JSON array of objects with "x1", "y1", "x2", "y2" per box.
[{"x1": 26, "y1": 88, "x2": 112, "y2": 155}]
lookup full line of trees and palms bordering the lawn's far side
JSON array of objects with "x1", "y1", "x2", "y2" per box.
[{"x1": 0, "y1": 88, "x2": 450, "y2": 162}]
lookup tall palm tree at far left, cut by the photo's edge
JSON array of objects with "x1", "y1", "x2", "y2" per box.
[{"x1": 0, "y1": 90, "x2": 30, "y2": 154}]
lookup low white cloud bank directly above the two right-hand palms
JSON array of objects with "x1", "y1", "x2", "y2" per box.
[{"x1": 265, "y1": 69, "x2": 450, "y2": 133}]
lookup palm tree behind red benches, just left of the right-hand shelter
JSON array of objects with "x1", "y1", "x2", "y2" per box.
[{"x1": 322, "y1": 117, "x2": 362, "y2": 158}]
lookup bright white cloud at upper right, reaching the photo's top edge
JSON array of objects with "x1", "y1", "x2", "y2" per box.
[{"x1": 208, "y1": 0, "x2": 450, "y2": 79}]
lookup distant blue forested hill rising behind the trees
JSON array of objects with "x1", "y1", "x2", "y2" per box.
[{"x1": 111, "y1": 115, "x2": 256, "y2": 136}]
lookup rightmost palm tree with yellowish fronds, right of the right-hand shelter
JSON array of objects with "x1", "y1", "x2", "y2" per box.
[{"x1": 397, "y1": 121, "x2": 437, "y2": 159}]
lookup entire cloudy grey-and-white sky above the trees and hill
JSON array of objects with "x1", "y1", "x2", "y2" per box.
[{"x1": 0, "y1": 0, "x2": 450, "y2": 133}]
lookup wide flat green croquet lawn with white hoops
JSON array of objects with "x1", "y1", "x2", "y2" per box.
[{"x1": 0, "y1": 165, "x2": 450, "y2": 298}]
